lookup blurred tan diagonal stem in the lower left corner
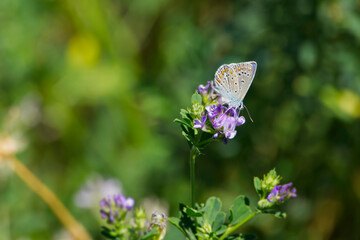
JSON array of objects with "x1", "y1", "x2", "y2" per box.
[{"x1": 0, "y1": 156, "x2": 91, "y2": 240}]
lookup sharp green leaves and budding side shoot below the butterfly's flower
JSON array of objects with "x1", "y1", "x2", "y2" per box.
[{"x1": 169, "y1": 169, "x2": 296, "y2": 240}]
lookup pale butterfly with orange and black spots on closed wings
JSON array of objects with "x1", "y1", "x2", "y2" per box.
[{"x1": 214, "y1": 61, "x2": 257, "y2": 109}]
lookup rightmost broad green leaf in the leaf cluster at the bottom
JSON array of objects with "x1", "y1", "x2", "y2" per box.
[{"x1": 229, "y1": 195, "x2": 252, "y2": 225}]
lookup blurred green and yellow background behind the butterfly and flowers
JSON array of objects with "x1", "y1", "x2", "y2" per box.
[{"x1": 0, "y1": 0, "x2": 360, "y2": 240}]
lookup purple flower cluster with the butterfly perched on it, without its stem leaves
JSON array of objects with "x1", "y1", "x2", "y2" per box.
[{"x1": 193, "y1": 81, "x2": 245, "y2": 143}]
